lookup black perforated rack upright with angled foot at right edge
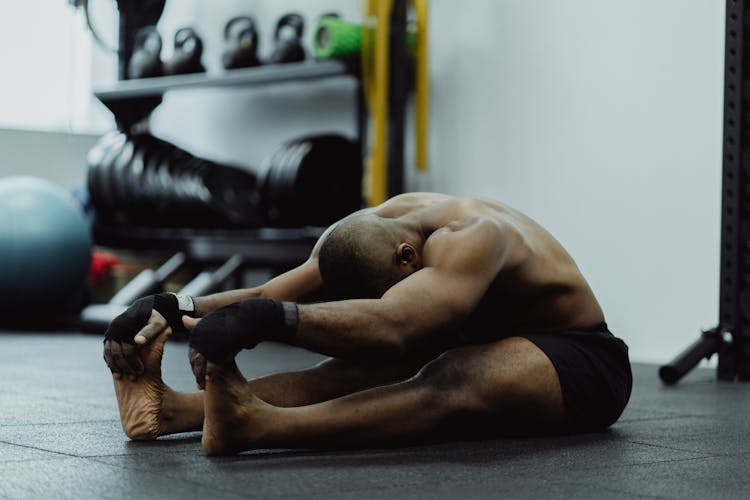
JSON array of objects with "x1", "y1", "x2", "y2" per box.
[{"x1": 659, "y1": 0, "x2": 750, "y2": 384}]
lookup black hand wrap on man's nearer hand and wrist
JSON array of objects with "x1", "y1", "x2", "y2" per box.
[{"x1": 190, "y1": 298, "x2": 299, "y2": 363}]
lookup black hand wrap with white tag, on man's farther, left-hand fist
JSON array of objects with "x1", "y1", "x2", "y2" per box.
[{"x1": 104, "y1": 292, "x2": 195, "y2": 344}]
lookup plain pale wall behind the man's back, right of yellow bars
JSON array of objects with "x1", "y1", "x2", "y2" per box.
[{"x1": 431, "y1": 0, "x2": 724, "y2": 361}]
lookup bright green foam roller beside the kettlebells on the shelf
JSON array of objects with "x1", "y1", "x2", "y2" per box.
[{"x1": 313, "y1": 16, "x2": 417, "y2": 59}]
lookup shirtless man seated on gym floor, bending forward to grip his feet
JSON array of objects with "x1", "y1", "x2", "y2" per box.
[{"x1": 104, "y1": 193, "x2": 632, "y2": 455}]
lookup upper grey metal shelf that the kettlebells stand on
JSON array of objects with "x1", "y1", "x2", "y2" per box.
[{"x1": 94, "y1": 60, "x2": 354, "y2": 105}]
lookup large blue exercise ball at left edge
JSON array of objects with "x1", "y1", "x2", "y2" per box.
[{"x1": 0, "y1": 176, "x2": 92, "y2": 314}]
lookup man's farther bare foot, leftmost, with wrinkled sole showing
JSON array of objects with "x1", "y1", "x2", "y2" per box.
[{"x1": 113, "y1": 330, "x2": 203, "y2": 441}]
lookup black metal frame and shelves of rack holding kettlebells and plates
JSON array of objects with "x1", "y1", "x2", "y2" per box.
[{"x1": 93, "y1": 0, "x2": 418, "y2": 270}]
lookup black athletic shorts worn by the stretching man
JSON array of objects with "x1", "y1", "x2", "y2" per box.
[{"x1": 518, "y1": 323, "x2": 633, "y2": 432}]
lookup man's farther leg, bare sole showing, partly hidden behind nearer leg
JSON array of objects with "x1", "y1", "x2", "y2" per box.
[{"x1": 114, "y1": 333, "x2": 439, "y2": 440}]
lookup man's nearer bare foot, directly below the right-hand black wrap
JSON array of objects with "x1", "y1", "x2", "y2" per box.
[{"x1": 201, "y1": 360, "x2": 270, "y2": 455}]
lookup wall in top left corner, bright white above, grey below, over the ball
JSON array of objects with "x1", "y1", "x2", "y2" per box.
[{"x1": 0, "y1": 0, "x2": 116, "y2": 193}]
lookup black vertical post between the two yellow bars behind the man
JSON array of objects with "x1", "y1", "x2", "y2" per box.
[{"x1": 387, "y1": 0, "x2": 409, "y2": 197}]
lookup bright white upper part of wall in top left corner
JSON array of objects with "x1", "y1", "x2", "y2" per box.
[{"x1": 0, "y1": 0, "x2": 111, "y2": 133}]
